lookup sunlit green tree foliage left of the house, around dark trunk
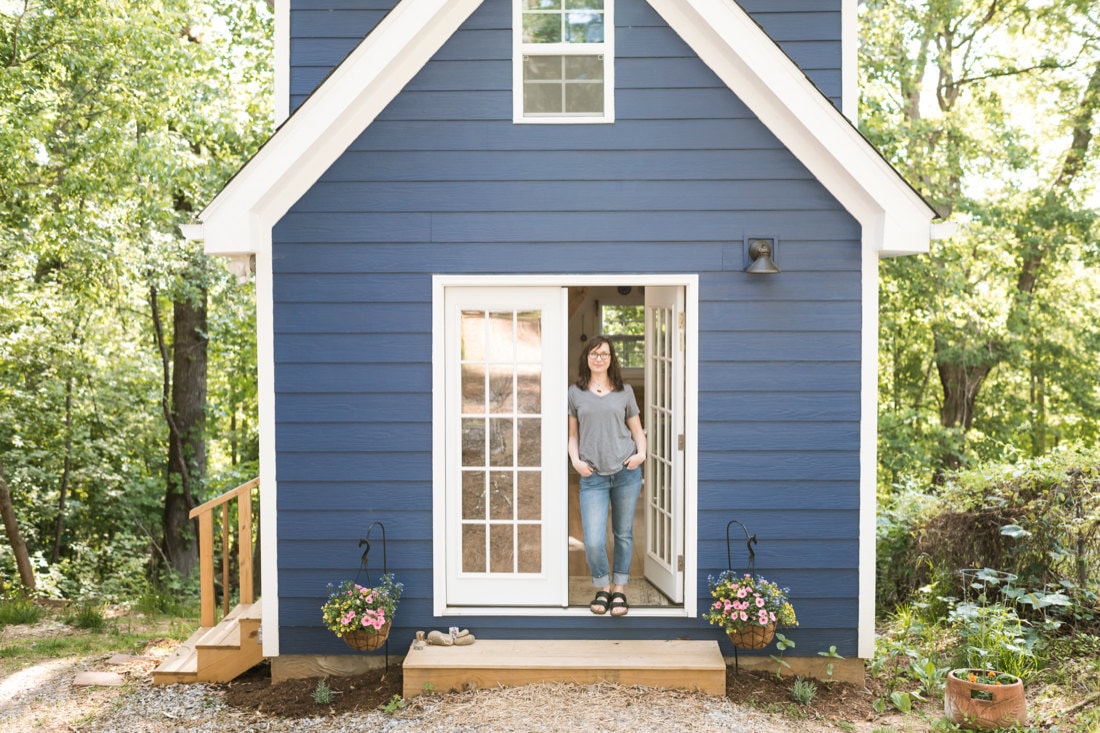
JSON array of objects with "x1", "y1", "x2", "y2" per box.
[{"x1": 0, "y1": 0, "x2": 272, "y2": 592}]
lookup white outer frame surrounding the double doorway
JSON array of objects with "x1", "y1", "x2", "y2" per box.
[{"x1": 432, "y1": 274, "x2": 699, "y2": 617}]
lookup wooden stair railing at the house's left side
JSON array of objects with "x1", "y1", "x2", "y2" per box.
[{"x1": 189, "y1": 478, "x2": 260, "y2": 626}]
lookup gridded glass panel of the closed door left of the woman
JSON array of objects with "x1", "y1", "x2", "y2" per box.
[{"x1": 460, "y1": 309, "x2": 542, "y2": 575}]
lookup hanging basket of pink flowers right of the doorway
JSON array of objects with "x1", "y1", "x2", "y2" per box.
[{"x1": 703, "y1": 570, "x2": 799, "y2": 649}]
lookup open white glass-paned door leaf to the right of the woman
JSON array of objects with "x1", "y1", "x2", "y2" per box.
[{"x1": 645, "y1": 286, "x2": 685, "y2": 603}]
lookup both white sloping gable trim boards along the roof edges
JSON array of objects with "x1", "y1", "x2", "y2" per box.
[{"x1": 196, "y1": 0, "x2": 934, "y2": 255}]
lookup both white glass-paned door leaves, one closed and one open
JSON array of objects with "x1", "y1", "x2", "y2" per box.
[{"x1": 437, "y1": 286, "x2": 684, "y2": 608}]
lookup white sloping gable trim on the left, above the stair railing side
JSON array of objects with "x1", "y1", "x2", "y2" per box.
[{"x1": 200, "y1": 0, "x2": 482, "y2": 254}]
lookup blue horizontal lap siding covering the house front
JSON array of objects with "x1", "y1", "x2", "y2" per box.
[{"x1": 273, "y1": 0, "x2": 862, "y2": 656}]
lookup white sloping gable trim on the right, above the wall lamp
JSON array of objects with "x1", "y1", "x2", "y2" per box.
[{"x1": 647, "y1": 0, "x2": 935, "y2": 254}]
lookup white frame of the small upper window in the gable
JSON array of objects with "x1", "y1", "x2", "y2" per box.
[{"x1": 512, "y1": 0, "x2": 615, "y2": 124}]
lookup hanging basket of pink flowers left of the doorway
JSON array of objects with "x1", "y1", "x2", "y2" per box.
[{"x1": 321, "y1": 573, "x2": 405, "y2": 652}]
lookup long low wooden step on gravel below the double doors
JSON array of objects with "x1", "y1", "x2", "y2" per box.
[{"x1": 402, "y1": 639, "x2": 726, "y2": 698}]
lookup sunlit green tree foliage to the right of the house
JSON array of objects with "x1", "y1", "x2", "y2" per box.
[{"x1": 860, "y1": 0, "x2": 1100, "y2": 484}]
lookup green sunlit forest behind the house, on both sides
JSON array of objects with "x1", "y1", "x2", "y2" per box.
[{"x1": 0, "y1": 0, "x2": 1100, "y2": 601}]
